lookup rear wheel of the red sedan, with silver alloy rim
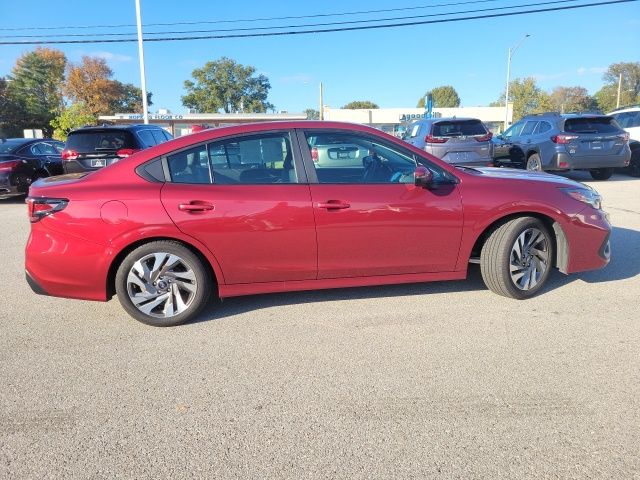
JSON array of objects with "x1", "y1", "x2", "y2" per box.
[{"x1": 115, "y1": 240, "x2": 213, "y2": 327}]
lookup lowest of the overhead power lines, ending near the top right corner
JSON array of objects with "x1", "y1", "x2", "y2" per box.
[{"x1": 0, "y1": 0, "x2": 639, "y2": 45}]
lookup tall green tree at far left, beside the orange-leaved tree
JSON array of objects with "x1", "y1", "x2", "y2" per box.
[{"x1": 6, "y1": 47, "x2": 67, "y2": 134}]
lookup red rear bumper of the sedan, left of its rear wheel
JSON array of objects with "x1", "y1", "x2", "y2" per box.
[{"x1": 25, "y1": 222, "x2": 113, "y2": 301}]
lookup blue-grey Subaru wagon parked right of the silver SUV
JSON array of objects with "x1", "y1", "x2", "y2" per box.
[{"x1": 493, "y1": 113, "x2": 631, "y2": 180}]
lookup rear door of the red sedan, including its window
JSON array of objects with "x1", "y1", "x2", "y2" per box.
[{"x1": 161, "y1": 131, "x2": 317, "y2": 284}]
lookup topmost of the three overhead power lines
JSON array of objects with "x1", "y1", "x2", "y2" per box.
[{"x1": 0, "y1": 0, "x2": 500, "y2": 31}]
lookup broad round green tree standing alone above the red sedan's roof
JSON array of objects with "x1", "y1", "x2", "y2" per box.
[{"x1": 182, "y1": 57, "x2": 273, "y2": 113}]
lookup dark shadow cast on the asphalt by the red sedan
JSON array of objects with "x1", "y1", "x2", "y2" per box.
[{"x1": 192, "y1": 227, "x2": 640, "y2": 323}]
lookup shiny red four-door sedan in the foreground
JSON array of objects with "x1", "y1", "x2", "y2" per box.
[{"x1": 26, "y1": 122, "x2": 611, "y2": 326}]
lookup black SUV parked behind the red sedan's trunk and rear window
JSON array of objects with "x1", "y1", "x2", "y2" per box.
[{"x1": 62, "y1": 125, "x2": 173, "y2": 173}]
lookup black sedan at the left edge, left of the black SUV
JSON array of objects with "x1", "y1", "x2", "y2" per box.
[{"x1": 0, "y1": 138, "x2": 64, "y2": 199}]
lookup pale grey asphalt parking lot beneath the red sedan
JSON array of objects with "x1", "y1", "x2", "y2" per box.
[{"x1": 0, "y1": 173, "x2": 640, "y2": 479}]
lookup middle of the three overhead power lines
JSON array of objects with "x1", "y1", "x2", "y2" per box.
[{"x1": 0, "y1": 0, "x2": 578, "y2": 38}]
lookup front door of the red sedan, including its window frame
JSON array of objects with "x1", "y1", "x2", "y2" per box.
[{"x1": 298, "y1": 129, "x2": 462, "y2": 279}]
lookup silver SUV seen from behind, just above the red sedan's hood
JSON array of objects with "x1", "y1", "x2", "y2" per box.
[{"x1": 403, "y1": 118, "x2": 493, "y2": 167}]
